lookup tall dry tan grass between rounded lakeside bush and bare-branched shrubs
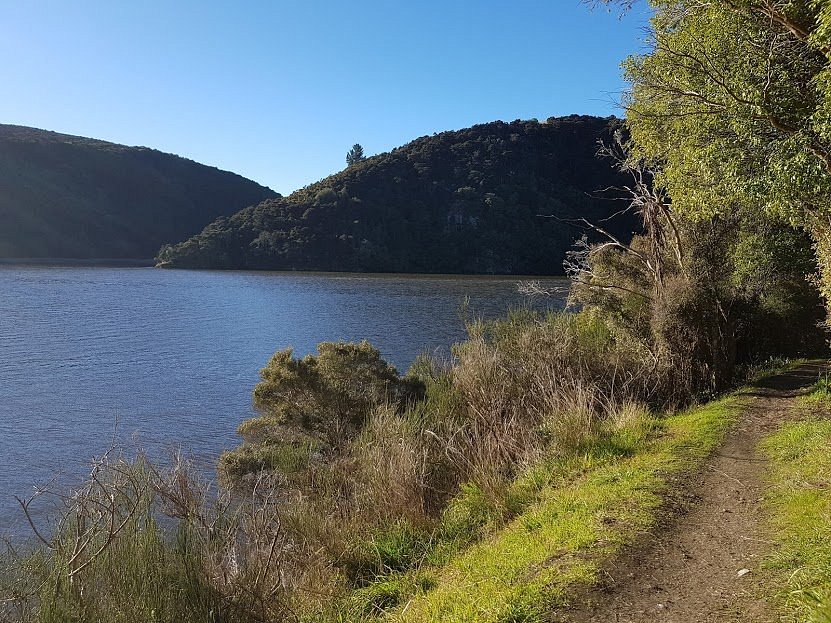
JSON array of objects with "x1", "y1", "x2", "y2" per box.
[{"x1": 438, "y1": 313, "x2": 654, "y2": 490}]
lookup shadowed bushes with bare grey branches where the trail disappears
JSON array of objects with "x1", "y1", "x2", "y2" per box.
[{"x1": 567, "y1": 129, "x2": 825, "y2": 394}]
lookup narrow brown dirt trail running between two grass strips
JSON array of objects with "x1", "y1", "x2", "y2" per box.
[{"x1": 555, "y1": 364, "x2": 827, "y2": 623}]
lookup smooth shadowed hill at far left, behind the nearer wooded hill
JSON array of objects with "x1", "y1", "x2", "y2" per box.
[{"x1": 0, "y1": 124, "x2": 276, "y2": 258}]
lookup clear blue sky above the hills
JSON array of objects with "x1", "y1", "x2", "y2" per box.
[{"x1": 0, "y1": 0, "x2": 647, "y2": 194}]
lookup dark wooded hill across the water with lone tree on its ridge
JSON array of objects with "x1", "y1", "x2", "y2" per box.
[{"x1": 158, "y1": 116, "x2": 633, "y2": 274}]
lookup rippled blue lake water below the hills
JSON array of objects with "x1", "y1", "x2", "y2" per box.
[{"x1": 0, "y1": 266, "x2": 559, "y2": 533}]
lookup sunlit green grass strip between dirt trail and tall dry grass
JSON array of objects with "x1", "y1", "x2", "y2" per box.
[{"x1": 336, "y1": 397, "x2": 740, "y2": 623}]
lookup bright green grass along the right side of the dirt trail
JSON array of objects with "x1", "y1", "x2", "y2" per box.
[{"x1": 761, "y1": 378, "x2": 831, "y2": 623}]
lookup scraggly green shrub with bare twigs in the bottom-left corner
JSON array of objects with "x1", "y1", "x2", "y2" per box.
[{"x1": 0, "y1": 451, "x2": 302, "y2": 622}]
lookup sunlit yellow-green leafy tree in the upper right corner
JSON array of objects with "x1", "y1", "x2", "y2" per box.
[{"x1": 594, "y1": 0, "x2": 831, "y2": 320}]
